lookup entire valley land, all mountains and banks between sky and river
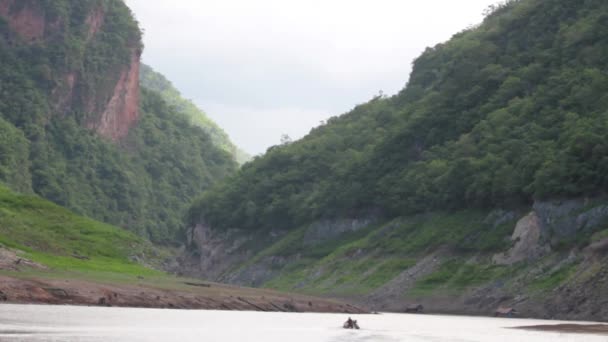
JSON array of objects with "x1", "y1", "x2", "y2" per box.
[{"x1": 0, "y1": 0, "x2": 608, "y2": 321}]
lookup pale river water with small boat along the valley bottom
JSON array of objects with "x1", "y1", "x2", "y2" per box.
[{"x1": 0, "y1": 305, "x2": 608, "y2": 342}]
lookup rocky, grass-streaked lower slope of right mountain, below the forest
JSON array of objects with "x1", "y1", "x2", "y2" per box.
[{"x1": 180, "y1": 198, "x2": 608, "y2": 321}]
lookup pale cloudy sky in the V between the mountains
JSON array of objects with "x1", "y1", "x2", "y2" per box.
[{"x1": 126, "y1": 0, "x2": 496, "y2": 155}]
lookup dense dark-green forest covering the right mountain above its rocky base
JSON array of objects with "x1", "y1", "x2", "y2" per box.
[{"x1": 190, "y1": 0, "x2": 608, "y2": 230}]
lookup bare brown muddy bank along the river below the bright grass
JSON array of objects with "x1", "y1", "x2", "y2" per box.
[{"x1": 0, "y1": 276, "x2": 366, "y2": 313}]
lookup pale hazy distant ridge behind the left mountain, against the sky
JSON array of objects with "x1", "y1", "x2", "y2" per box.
[{"x1": 139, "y1": 64, "x2": 251, "y2": 164}]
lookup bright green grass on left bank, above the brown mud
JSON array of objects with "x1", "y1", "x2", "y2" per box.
[{"x1": 0, "y1": 186, "x2": 161, "y2": 275}]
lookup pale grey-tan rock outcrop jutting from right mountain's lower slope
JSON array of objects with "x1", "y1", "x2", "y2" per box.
[{"x1": 493, "y1": 212, "x2": 550, "y2": 265}]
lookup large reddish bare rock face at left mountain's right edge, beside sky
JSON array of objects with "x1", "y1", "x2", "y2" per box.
[{"x1": 89, "y1": 51, "x2": 140, "y2": 141}]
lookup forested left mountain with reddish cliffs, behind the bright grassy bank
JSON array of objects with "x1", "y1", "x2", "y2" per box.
[{"x1": 0, "y1": 0, "x2": 237, "y2": 244}]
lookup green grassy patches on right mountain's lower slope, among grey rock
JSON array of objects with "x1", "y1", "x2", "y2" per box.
[{"x1": 244, "y1": 206, "x2": 608, "y2": 298}]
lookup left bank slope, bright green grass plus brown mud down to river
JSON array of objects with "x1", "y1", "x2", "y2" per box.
[{"x1": 0, "y1": 185, "x2": 361, "y2": 313}]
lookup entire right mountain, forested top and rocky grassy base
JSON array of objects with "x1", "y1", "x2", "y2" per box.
[{"x1": 184, "y1": 0, "x2": 608, "y2": 320}]
